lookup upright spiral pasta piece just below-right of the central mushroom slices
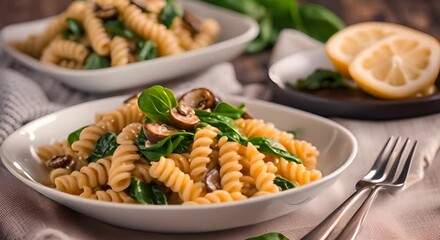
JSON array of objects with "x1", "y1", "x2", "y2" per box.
[{"x1": 189, "y1": 127, "x2": 217, "y2": 182}]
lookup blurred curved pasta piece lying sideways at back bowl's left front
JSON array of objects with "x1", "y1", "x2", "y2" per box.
[{"x1": 41, "y1": 39, "x2": 89, "y2": 64}]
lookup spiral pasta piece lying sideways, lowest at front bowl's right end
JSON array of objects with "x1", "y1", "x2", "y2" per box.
[{"x1": 275, "y1": 158, "x2": 322, "y2": 186}]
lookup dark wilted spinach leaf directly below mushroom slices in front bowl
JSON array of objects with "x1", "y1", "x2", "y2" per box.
[{"x1": 136, "y1": 131, "x2": 194, "y2": 162}]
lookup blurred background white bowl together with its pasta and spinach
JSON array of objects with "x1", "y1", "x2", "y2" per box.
[{"x1": 0, "y1": 0, "x2": 258, "y2": 92}]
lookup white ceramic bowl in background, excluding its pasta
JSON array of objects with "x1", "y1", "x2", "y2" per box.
[{"x1": 0, "y1": 0, "x2": 259, "y2": 93}]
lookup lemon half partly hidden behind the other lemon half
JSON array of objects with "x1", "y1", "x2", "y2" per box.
[{"x1": 326, "y1": 22, "x2": 416, "y2": 77}]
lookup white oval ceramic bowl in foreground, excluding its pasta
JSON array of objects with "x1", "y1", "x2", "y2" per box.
[{"x1": 0, "y1": 96, "x2": 357, "y2": 232}]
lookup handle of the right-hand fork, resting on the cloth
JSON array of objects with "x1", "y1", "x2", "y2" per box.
[{"x1": 336, "y1": 185, "x2": 383, "y2": 240}]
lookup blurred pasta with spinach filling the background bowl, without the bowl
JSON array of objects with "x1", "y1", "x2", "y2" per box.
[{"x1": 11, "y1": 0, "x2": 220, "y2": 69}]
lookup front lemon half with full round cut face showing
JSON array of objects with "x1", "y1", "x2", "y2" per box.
[{"x1": 349, "y1": 33, "x2": 440, "y2": 99}]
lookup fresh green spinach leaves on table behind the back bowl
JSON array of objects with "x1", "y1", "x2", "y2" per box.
[{"x1": 203, "y1": 0, "x2": 345, "y2": 53}]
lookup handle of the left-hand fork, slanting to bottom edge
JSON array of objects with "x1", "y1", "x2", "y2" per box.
[{"x1": 301, "y1": 186, "x2": 372, "y2": 240}]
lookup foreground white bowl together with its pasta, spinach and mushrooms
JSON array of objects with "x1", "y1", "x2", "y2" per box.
[{"x1": 0, "y1": 85, "x2": 357, "y2": 232}]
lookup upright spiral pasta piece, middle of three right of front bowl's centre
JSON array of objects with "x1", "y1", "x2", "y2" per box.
[{"x1": 218, "y1": 137, "x2": 246, "y2": 200}]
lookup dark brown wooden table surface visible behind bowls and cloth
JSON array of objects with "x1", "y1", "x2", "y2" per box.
[{"x1": 0, "y1": 0, "x2": 440, "y2": 83}]
